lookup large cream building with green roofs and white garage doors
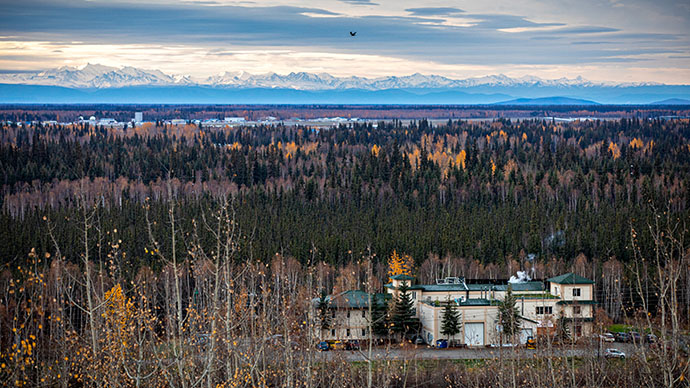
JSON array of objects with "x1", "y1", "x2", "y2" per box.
[{"x1": 385, "y1": 273, "x2": 596, "y2": 346}]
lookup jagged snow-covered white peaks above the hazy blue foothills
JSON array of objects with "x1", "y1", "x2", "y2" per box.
[{"x1": 0, "y1": 64, "x2": 652, "y2": 90}]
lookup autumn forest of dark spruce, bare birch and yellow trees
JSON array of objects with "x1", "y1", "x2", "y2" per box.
[{"x1": 0, "y1": 107, "x2": 690, "y2": 387}]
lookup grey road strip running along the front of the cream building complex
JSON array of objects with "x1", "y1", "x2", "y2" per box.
[{"x1": 317, "y1": 343, "x2": 637, "y2": 361}]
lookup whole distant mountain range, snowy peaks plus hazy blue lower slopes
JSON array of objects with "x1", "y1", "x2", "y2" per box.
[{"x1": 0, "y1": 64, "x2": 690, "y2": 105}]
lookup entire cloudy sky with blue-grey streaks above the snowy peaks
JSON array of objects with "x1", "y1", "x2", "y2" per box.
[{"x1": 0, "y1": 0, "x2": 690, "y2": 84}]
